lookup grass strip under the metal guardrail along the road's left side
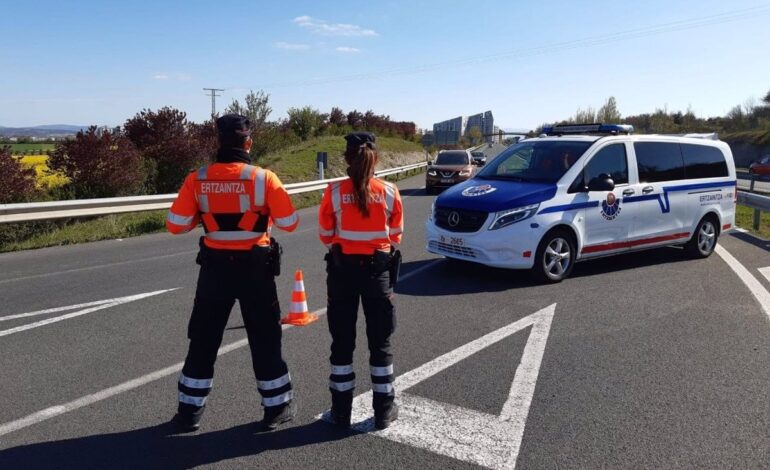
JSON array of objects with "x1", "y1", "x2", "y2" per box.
[{"x1": 0, "y1": 170, "x2": 421, "y2": 253}]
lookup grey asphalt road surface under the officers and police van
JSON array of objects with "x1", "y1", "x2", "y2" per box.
[{"x1": 0, "y1": 176, "x2": 770, "y2": 469}]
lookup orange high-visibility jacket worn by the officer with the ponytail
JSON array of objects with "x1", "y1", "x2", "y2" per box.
[{"x1": 318, "y1": 178, "x2": 404, "y2": 255}]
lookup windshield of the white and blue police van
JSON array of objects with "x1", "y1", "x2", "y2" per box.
[{"x1": 477, "y1": 140, "x2": 593, "y2": 183}]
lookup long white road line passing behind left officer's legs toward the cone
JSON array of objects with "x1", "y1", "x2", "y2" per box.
[{"x1": 0, "y1": 308, "x2": 326, "y2": 436}]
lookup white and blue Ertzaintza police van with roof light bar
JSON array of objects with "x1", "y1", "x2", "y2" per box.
[{"x1": 426, "y1": 124, "x2": 737, "y2": 282}]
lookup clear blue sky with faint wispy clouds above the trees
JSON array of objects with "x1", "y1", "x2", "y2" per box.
[{"x1": 0, "y1": 0, "x2": 770, "y2": 128}]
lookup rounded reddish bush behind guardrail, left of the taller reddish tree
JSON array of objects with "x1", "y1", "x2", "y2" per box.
[{"x1": 48, "y1": 126, "x2": 146, "y2": 199}]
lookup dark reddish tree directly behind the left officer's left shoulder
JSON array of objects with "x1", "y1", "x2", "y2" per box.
[{"x1": 123, "y1": 107, "x2": 216, "y2": 193}]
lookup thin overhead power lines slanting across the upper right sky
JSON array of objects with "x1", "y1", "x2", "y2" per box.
[{"x1": 243, "y1": 5, "x2": 770, "y2": 88}]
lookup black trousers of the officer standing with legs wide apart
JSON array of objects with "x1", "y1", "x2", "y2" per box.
[{"x1": 178, "y1": 248, "x2": 293, "y2": 414}]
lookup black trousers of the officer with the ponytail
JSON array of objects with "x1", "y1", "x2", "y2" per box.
[{"x1": 326, "y1": 255, "x2": 396, "y2": 414}]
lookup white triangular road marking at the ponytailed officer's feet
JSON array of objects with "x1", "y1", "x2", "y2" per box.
[{"x1": 322, "y1": 304, "x2": 556, "y2": 469}]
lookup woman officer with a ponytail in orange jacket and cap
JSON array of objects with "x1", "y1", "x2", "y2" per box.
[{"x1": 319, "y1": 132, "x2": 403, "y2": 429}]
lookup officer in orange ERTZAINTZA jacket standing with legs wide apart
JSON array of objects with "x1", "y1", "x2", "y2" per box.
[{"x1": 166, "y1": 114, "x2": 299, "y2": 432}]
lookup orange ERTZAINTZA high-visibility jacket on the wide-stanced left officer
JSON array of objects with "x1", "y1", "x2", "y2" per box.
[{"x1": 166, "y1": 162, "x2": 299, "y2": 250}]
